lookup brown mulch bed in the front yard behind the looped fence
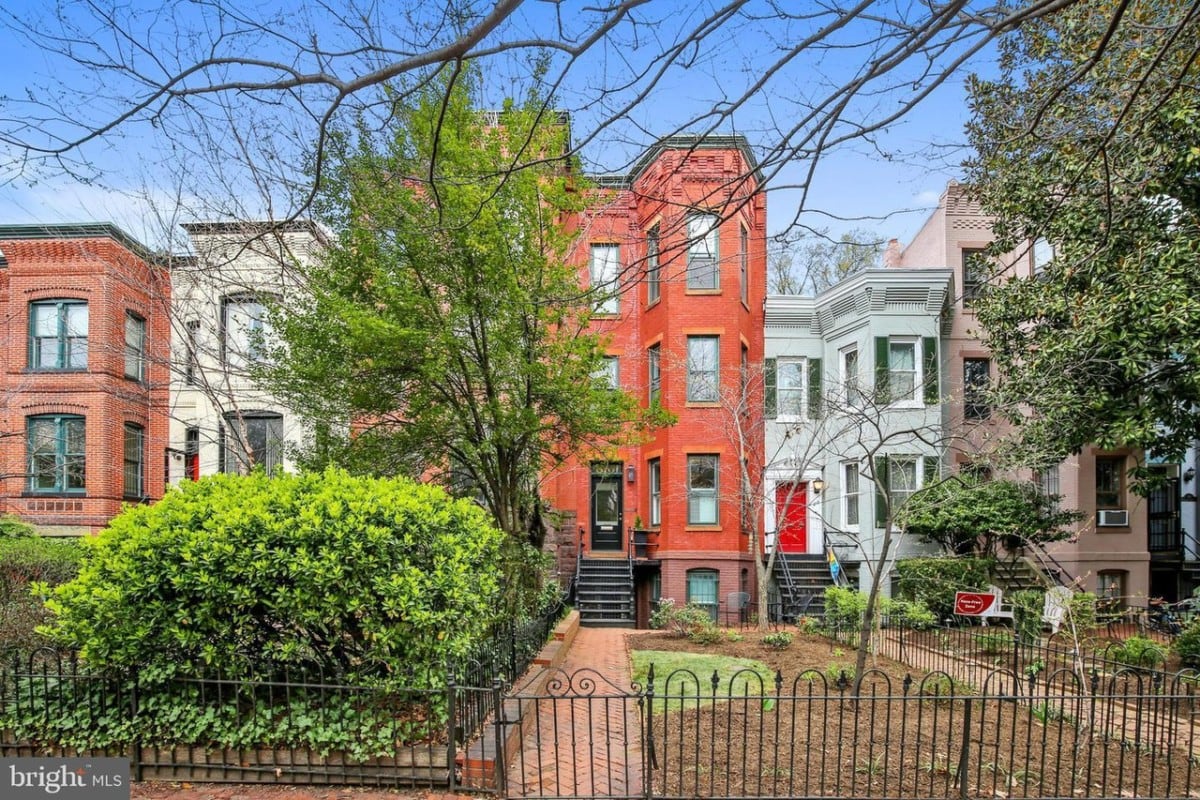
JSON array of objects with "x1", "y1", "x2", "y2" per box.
[{"x1": 630, "y1": 631, "x2": 1200, "y2": 798}]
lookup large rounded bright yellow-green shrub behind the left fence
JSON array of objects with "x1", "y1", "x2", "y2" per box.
[{"x1": 47, "y1": 470, "x2": 504, "y2": 680}]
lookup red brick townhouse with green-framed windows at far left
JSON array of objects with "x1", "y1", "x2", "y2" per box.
[{"x1": 0, "y1": 224, "x2": 170, "y2": 534}]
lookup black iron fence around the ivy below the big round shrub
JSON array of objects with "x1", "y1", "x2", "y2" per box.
[{"x1": 0, "y1": 594, "x2": 563, "y2": 790}]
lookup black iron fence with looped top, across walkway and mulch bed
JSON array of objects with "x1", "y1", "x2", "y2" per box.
[{"x1": 504, "y1": 669, "x2": 1200, "y2": 800}]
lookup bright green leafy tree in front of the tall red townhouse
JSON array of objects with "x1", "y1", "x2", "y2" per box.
[{"x1": 266, "y1": 70, "x2": 661, "y2": 546}]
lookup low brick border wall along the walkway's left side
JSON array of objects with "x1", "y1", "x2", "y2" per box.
[{"x1": 456, "y1": 609, "x2": 580, "y2": 789}]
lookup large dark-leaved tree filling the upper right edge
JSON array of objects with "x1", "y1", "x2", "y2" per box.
[{"x1": 968, "y1": 0, "x2": 1200, "y2": 459}]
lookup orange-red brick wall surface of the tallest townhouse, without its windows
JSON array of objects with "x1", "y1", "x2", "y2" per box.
[{"x1": 545, "y1": 137, "x2": 767, "y2": 618}]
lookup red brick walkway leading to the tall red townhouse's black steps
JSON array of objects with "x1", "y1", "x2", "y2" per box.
[{"x1": 509, "y1": 627, "x2": 642, "y2": 798}]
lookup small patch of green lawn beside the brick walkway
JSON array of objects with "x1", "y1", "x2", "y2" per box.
[{"x1": 634, "y1": 650, "x2": 775, "y2": 711}]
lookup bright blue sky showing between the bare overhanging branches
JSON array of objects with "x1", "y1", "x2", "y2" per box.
[{"x1": 0, "y1": 0, "x2": 990, "y2": 250}]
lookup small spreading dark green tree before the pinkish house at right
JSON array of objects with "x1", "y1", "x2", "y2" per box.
[{"x1": 896, "y1": 477, "x2": 1081, "y2": 557}]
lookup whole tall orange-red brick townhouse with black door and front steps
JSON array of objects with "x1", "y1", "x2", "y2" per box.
[{"x1": 545, "y1": 136, "x2": 767, "y2": 625}]
